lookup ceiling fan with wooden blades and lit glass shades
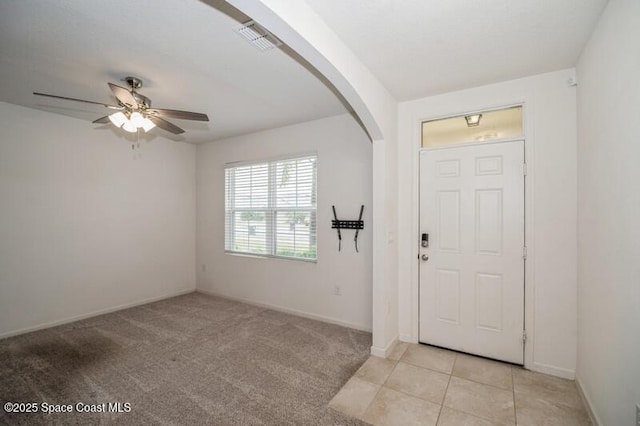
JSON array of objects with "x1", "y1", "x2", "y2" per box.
[{"x1": 33, "y1": 77, "x2": 209, "y2": 135}]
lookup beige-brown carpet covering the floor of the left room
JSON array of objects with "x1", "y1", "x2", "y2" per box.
[{"x1": 0, "y1": 293, "x2": 371, "y2": 425}]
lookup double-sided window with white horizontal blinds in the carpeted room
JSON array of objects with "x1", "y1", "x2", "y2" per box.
[{"x1": 225, "y1": 155, "x2": 317, "y2": 261}]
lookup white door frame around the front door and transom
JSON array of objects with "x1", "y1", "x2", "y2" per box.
[{"x1": 410, "y1": 98, "x2": 535, "y2": 369}]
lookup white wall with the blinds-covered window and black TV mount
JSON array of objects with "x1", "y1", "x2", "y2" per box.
[{"x1": 197, "y1": 115, "x2": 372, "y2": 330}]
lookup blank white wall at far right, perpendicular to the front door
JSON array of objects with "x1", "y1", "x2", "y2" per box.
[{"x1": 577, "y1": 0, "x2": 640, "y2": 425}]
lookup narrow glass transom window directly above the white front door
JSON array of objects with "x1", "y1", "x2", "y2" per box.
[{"x1": 422, "y1": 105, "x2": 524, "y2": 148}]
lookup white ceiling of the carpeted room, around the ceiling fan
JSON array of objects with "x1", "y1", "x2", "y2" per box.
[{"x1": 0, "y1": 0, "x2": 347, "y2": 143}]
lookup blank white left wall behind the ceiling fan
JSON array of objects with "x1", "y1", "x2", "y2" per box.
[{"x1": 0, "y1": 103, "x2": 195, "y2": 337}]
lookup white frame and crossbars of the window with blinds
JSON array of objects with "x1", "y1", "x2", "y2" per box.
[{"x1": 224, "y1": 151, "x2": 318, "y2": 263}]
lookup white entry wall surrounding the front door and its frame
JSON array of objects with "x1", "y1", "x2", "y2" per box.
[{"x1": 398, "y1": 70, "x2": 577, "y2": 378}]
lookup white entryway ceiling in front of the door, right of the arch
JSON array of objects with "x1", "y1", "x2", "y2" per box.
[{"x1": 307, "y1": 0, "x2": 606, "y2": 100}]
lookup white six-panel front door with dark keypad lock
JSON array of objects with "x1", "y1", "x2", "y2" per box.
[{"x1": 419, "y1": 141, "x2": 524, "y2": 364}]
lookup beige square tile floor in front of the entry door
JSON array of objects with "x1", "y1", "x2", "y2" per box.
[{"x1": 329, "y1": 343, "x2": 591, "y2": 426}]
